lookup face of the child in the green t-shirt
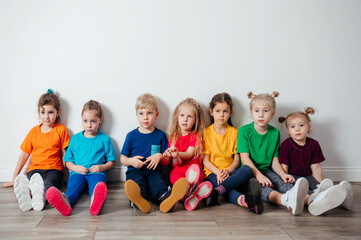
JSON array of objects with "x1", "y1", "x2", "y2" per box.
[{"x1": 251, "y1": 101, "x2": 275, "y2": 128}]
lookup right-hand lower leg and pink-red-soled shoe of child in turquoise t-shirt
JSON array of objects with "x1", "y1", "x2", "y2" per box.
[{"x1": 86, "y1": 173, "x2": 108, "y2": 215}]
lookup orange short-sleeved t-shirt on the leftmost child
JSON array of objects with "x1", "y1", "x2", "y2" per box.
[{"x1": 20, "y1": 124, "x2": 70, "y2": 172}]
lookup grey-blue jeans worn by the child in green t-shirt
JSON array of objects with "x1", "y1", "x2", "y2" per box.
[{"x1": 261, "y1": 171, "x2": 293, "y2": 203}]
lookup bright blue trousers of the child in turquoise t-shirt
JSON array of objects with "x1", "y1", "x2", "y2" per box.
[{"x1": 65, "y1": 173, "x2": 107, "y2": 206}]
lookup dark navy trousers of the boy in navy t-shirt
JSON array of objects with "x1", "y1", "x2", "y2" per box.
[{"x1": 126, "y1": 169, "x2": 168, "y2": 205}]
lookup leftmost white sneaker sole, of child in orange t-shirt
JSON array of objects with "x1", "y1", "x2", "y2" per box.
[{"x1": 14, "y1": 173, "x2": 32, "y2": 212}]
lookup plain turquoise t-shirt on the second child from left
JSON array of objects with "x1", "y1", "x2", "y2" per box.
[{"x1": 64, "y1": 131, "x2": 117, "y2": 175}]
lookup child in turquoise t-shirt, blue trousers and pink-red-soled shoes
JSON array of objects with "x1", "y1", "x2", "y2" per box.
[{"x1": 46, "y1": 100, "x2": 116, "y2": 216}]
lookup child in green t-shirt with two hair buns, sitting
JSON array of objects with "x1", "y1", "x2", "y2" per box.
[{"x1": 237, "y1": 92, "x2": 308, "y2": 215}]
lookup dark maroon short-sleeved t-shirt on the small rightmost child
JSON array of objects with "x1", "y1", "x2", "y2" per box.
[{"x1": 279, "y1": 137, "x2": 325, "y2": 176}]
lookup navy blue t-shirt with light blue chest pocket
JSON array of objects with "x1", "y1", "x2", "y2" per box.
[{"x1": 121, "y1": 128, "x2": 168, "y2": 171}]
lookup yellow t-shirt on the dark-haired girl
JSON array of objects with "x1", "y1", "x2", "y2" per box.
[{"x1": 202, "y1": 124, "x2": 238, "y2": 177}]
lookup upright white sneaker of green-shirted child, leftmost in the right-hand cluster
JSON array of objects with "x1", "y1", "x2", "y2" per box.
[{"x1": 285, "y1": 178, "x2": 308, "y2": 215}]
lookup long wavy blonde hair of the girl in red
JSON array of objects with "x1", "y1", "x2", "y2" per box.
[{"x1": 169, "y1": 98, "x2": 205, "y2": 157}]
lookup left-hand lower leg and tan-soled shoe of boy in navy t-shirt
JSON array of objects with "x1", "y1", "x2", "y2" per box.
[{"x1": 124, "y1": 170, "x2": 152, "y2": 213}]
